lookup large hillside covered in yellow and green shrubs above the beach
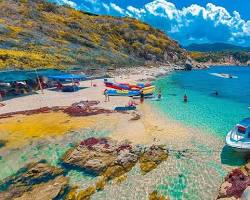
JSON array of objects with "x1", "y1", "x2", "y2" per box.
[{"x1": 0, "y1": 0, "x2": 187, "y2": 69}]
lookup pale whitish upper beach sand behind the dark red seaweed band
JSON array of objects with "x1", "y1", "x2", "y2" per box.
[{"x1": 0, "y1": 67, "x2": 174, "y2": 114}]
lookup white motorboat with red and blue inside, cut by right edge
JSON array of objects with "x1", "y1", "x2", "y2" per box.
[{"x1": 226, "y1": 118, "x2": 250, "y2": 152}]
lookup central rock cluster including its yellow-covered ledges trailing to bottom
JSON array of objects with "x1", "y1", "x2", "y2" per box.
[{"x1": 62, "y1": 137, "x2": 168, "y2": 200}]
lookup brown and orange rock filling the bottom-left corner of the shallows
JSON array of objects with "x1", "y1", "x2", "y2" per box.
[{"x1": 0, "y1": 161, "x2": 68, "y2": 200}]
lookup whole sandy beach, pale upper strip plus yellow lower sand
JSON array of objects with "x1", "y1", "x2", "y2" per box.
[{"x1": 0, "y1": 67, "x2": 204, "y2": 148}]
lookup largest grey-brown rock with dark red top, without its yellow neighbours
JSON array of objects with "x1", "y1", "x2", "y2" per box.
[{"x1": 62, "y1": 137, "x2": 138, "y2": 175}]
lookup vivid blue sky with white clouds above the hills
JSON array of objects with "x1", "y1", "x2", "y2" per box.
[{"x1": 51, "y1": 0, "x2": 250, "y2": 46}]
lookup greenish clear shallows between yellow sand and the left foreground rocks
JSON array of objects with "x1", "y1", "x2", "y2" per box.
[{"x1": 0, "y1": 130, "x2": 109, "y2": 185}]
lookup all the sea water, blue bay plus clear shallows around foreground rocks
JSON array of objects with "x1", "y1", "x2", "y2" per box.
[{"x1": 0, "y1": 67, "x2": 250, "y2": 200}]
